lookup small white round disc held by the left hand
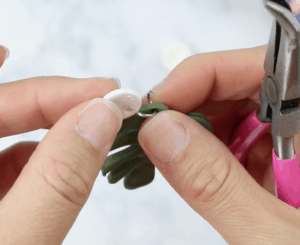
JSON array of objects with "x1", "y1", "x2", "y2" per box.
[{"x1": 103, "y1": 89, "x2": 142, "y2": 119}]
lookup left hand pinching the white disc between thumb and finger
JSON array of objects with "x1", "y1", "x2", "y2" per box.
[{"x1": 0, "y1": 47, "x2": 122, "y2": 245}]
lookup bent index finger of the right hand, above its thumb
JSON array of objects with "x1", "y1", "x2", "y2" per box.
[{"x1": 143, "y1": 45, "x2": 267, "y2": 113}]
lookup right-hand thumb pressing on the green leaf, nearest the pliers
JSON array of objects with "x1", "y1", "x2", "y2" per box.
[{"x1": 139, "y1": 111, "x2": 299, "y2": 244}]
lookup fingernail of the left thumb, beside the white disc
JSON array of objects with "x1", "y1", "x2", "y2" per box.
[{"x1": 74, "y1": 98, "x2": 123, "y2": 150}]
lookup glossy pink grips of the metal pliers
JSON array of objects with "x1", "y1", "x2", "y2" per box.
[{"x1": 229, "y1": 110, "x2": 300, "y2": 208}]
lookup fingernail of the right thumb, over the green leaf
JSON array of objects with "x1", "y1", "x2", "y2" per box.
[{"x1": 139, "y1": 112, "x2": 190, "y2": 164}]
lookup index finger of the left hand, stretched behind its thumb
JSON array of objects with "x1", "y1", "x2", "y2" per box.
[{"x1": 0, "y1": 76, "x2": 119, "y2": 137}]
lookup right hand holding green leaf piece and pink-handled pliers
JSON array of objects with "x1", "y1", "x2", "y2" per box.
[{"x1": 138, "y1": 3, "x2": 300, "y2": 245}]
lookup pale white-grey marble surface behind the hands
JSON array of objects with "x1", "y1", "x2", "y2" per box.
[{"x1": 0, "y1": 0, "x2": 272, "y2": 245}]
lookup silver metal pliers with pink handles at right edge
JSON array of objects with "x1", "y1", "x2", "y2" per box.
[{"x1": 229, "y1": 0, "x2": 300, "y2": 208}]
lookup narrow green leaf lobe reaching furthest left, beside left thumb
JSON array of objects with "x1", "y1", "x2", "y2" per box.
[{"x1": 102, "y1": 144, "x2": 145, "y2": 176}]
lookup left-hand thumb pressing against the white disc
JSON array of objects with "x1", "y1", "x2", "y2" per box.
[{"x1": 0, "y1": 99, "x2": 122, "y2": 245}]
